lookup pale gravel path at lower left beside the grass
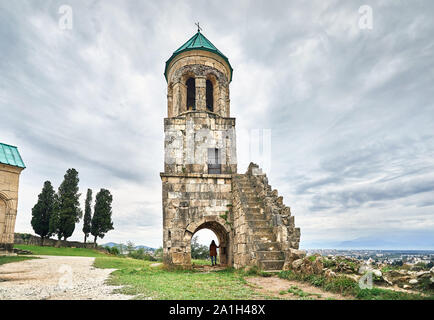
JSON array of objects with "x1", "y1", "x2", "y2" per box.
[{"x1": 0, "y1": 256, "x2": 132, "y2": 300}]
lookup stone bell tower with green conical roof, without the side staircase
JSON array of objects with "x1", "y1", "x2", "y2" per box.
[{"x1": 161, "y1": 30, "x2": 237, "y2": 265}]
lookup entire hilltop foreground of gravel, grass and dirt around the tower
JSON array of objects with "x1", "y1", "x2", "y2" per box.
[{"x1": 0, "y1": 247, "x2": 432, "y2": 300}]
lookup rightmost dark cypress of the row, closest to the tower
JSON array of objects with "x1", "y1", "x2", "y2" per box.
[{"x1": 90, "y1": 189, "x2": 113, "y2": 244}]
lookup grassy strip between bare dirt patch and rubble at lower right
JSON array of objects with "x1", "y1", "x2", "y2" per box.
[{"x1": 278, "y1": 271, "x2": 434, "y2": 300}]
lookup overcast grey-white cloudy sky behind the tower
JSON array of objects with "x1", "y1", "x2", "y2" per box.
[{"x1": 0, "y1": 0, "x2": 434, "y2": 249}]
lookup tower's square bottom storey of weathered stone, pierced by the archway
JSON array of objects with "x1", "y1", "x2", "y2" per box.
[{"x1": 161, "y1": 173, "x2": 233, "y2": 266}]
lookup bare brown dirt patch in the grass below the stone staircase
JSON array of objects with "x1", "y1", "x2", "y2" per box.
[{"x1": 246, "y1": 277, "x2": 345, "y2": 300}]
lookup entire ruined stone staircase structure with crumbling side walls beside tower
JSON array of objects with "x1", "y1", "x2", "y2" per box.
[{"x1": 232, "y1": 163, "x2": 300, "y2": 270}]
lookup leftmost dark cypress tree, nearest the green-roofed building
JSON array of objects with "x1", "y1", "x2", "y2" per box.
[{"x1": 31, "y1": 181, "x2": 55, "y2": 246}]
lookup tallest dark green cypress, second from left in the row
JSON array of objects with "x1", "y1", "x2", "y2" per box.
[{"x1": 50, "y1": 169, "x2": 82, "y2": 240}]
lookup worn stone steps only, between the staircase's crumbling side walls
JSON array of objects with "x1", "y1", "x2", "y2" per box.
[{"x1": 234, "y1": 174, "x2": 285, "y2": 271}]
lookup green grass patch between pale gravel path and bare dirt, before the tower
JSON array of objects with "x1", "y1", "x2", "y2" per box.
[{"x1": 94, "y1": 257, "x2": 265, "y2": 300}]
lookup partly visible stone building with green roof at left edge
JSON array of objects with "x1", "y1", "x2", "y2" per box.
[{"x1": 0, "y1": 142, "x2": 26, "y2": 254}]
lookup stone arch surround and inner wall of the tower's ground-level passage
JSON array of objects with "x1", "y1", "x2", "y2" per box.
[{"x1": 185, "y1": 217, "x2": 233, "y2": 266}]
